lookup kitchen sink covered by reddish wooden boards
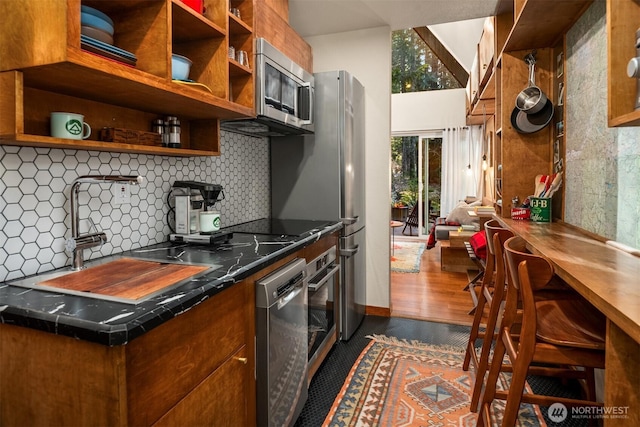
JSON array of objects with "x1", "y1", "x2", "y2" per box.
[{"x1": 8, "y1": 256, "x2": 221, "y2": 304}]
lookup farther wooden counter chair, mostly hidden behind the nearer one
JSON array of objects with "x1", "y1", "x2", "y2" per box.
[{"x1": 462, "y1": 220, "x2": 513, "y2": 412}]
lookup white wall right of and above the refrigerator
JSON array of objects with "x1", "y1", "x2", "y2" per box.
[{"x1": 305, "y1": 27, "x2": 391, "y2": 308}]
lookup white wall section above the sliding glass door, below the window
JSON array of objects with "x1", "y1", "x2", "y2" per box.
[{"x1": 391, "y1": 89, "x2": 466, "y2": 134}]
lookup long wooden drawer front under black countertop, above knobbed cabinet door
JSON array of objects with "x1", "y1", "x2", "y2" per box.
[{"x1": 127, "y1": 281, "x2": 254, "y2": 425}]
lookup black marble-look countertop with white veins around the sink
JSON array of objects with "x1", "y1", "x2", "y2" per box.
[{"x1": 0, "y1": 221, "x2": 342, "y2": 346}]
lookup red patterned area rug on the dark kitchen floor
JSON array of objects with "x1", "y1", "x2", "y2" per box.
[{"x1": 323, "y1": 335, "x2": 546, "y2": 427}]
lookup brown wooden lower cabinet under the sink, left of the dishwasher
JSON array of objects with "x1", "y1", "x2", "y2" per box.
[{"x1": 0, "y1": 280, "x2": 255, "y2": 426}]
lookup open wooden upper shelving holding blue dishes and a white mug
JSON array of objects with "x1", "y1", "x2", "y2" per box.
[{"x1": 0, "y1": 0, "x2": 255, "y2": 156}]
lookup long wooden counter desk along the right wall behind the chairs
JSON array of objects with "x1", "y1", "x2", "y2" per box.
[{"x1": 497, "y1": 218, "x2": 640, "y2": 427}]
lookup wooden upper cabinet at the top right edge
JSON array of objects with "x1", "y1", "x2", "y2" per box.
[{"x1": 607, "y1": 0, "x2": 640, "y2": 126}]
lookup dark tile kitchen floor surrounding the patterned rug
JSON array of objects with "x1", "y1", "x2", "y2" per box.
[{"x1": 295, "y1": 316, "x2": 588, "y2": 427}]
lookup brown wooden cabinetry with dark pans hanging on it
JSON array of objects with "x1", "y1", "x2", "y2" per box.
[{"x1": 471, "y1": 0, "x2": 593, "y2": 217}]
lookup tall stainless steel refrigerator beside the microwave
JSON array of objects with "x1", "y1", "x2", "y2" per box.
[{"x1": 271, "y1": 71, "x2": 366, "y2": 340}]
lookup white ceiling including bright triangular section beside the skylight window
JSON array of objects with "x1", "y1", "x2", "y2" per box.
[{"x1": 289, "y1": 0, "x2": 500, "y2": 70}]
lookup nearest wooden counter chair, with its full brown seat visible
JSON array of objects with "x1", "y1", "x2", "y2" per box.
[{"x1": 477, "y1": 237, "x2": 606, "y2": 426}]
